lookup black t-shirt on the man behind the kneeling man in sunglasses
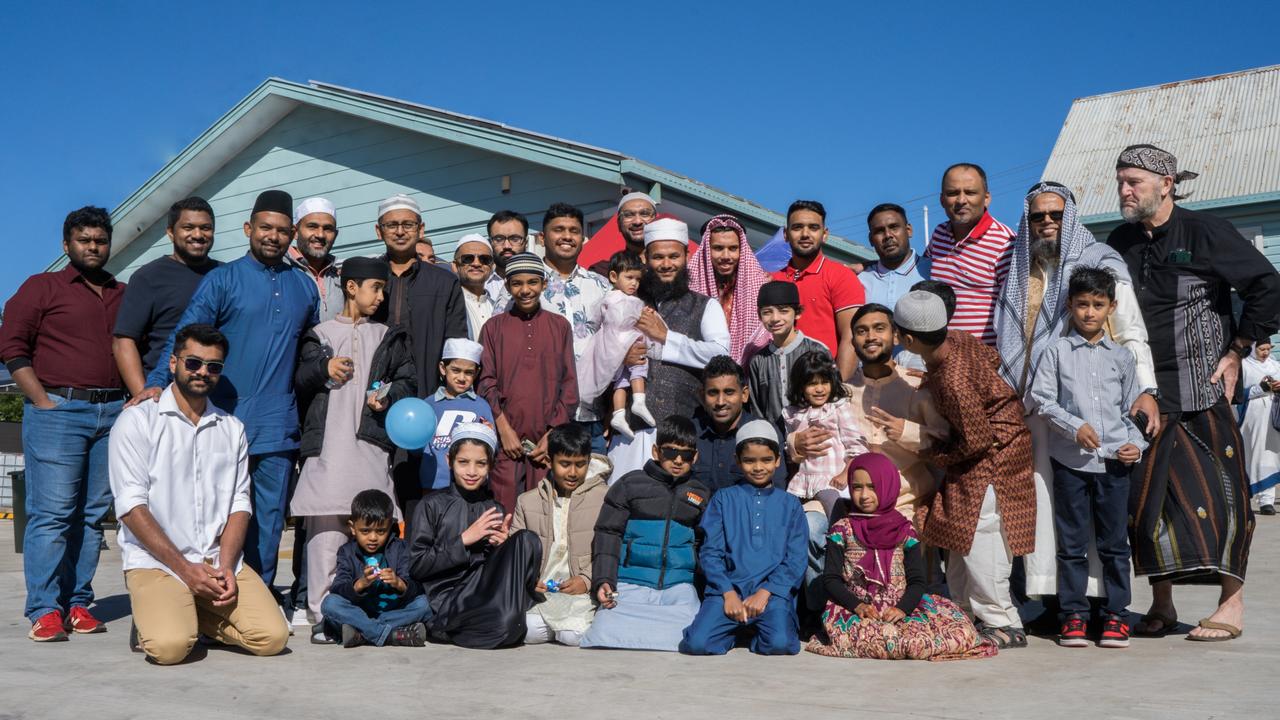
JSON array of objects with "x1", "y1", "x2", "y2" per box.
[{"x1": 113, "y1": 255, "x2": 221, "y2": 374}]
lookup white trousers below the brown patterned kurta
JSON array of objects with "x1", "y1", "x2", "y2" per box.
[{"x1": 947, "y1": 486, "x2": 1023, "y2": 628}]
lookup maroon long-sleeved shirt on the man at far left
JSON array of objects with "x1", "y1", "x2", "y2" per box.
[{"x1": 0, "y1": 265, "x2": 124, "y2": 388}]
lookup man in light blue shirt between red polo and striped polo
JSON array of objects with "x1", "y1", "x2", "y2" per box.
[{"x1": 858, "y1": 202, "x2": 932, "y2": 307}]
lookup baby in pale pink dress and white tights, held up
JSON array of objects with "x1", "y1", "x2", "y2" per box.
[{"x1": 577, "y1": 250, "x2": 655, "y2": 438}]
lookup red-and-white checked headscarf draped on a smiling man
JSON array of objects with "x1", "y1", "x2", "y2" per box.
[{"x1": 689, "y1": 215, "x2": 773, "y2": 365}]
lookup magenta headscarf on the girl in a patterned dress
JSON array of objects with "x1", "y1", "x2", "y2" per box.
[{"x1": 849, "y1": 452, "x2": 915, "y2": 585}]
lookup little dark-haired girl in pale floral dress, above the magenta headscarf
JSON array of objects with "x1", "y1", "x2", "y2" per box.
[{"x1": 782, "y1": 351, "x2": 867, "y2": 499}]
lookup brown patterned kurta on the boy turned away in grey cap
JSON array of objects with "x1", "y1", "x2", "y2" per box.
[{"x1": 923, "y1": 331, "x2": 1036, "y2": 555}]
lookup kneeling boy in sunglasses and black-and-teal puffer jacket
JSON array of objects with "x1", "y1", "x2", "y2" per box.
[{"x1": 581, "y1": 415, "x2": 712, "y2": 651}]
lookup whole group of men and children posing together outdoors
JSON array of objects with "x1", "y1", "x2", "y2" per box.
[{"x1": 0, "y1": 145, "x2": 1280, "y2": 664}]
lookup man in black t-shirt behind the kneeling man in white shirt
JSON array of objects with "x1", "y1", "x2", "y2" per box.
[{"x1": 111, "y1": 196, "x2": 221, "y2": 395}]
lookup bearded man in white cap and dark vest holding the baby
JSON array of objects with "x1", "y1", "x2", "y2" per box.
[{"x1": 609, "y1": 218, "x2": 730, "y2": 477}]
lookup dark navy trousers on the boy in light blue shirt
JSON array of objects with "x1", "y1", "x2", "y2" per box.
[{"x1": 1053, "y1": 460, "x2": 1130, "y2": 620}]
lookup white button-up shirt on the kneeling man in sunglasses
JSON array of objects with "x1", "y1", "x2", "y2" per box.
[{"x1": 109, "y1": 386, "x2": 251, "y2": 578}]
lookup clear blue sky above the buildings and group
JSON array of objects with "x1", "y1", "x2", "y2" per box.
[{"x1": 0, "y1": 0, "x2": 1280, "y2": 300}]
